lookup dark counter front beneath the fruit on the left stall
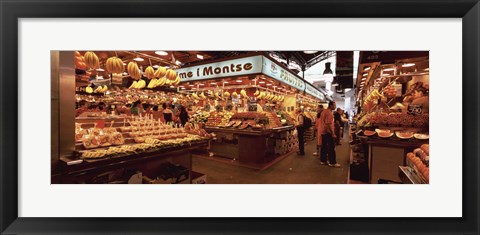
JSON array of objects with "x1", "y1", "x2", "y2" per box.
[{"x1": 56, "y1": 140, "x2": 208, "y2": 183}]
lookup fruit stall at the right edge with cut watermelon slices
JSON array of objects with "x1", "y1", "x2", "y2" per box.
[{"x1": 355, "y1": 53, "x2": 429, "y2": 183}]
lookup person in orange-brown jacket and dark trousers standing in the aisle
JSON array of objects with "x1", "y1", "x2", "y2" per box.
[{"x1": 319, "y1": 101, "x2": 340, "y2": 167}]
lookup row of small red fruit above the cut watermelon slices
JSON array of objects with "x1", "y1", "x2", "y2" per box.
[{"x1": 358, "y1": 113, "x2": 429, "y2": 128}]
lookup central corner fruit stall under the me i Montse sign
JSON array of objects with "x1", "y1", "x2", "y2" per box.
[{"x1": 172, "y1": 54, "x2": 325, "y2": 168}]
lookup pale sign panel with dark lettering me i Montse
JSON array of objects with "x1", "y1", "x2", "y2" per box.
[{"x1": 176, "y1": 55, "x2": 262, "y2": 82}]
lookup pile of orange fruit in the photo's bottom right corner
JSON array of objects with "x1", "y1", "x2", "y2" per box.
[{"x1": 407, "y1": 144, "x2": 430, "y2": 183}]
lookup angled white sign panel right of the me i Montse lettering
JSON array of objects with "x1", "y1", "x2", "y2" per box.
[{"x1": 262, "y1": 56, "x2": 305, "y2": 91}]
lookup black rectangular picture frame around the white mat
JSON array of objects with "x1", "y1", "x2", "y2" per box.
[{"x1": 0, "y1": 0, "x2": 480, "y2": 234}]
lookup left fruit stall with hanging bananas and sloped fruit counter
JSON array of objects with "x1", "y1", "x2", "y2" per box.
[{"x1": 52, "y1": 51, "x2": 211, "y2": 184}]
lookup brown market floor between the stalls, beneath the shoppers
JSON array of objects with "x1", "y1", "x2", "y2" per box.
[{"x1": 193, "y1": 132, "x2": 349, "y2": 184}]
